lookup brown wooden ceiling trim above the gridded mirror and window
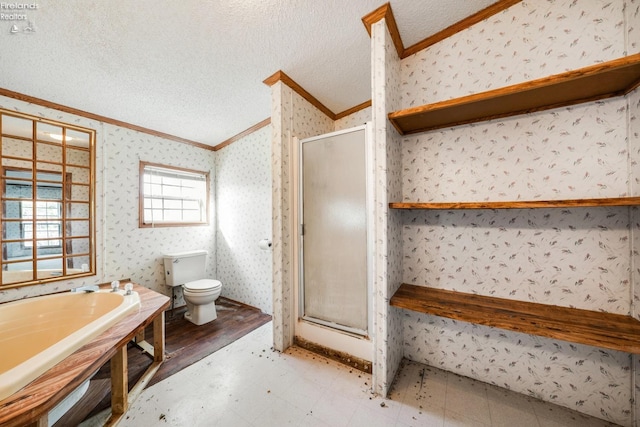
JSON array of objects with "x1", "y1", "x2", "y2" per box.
[{"x1": 0, "y1": 88, "x2": 213, "y2": 150}]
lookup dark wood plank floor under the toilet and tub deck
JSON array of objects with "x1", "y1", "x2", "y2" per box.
[{"x1": 55, "y1": 297, "x2": 271, "y2": 427}]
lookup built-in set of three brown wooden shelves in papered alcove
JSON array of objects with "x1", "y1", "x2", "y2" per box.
[{"x1": 389, "y1": 54, "x2": 640, "y2": 354}]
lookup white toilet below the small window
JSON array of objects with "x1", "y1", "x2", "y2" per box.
[{"x1": 164, "y1": 250, "x2": 222, "y2": 325}]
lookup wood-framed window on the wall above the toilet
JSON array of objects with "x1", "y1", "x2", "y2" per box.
[{"x1": 140, "y1": 162, "x2": 209, "y2": 227}]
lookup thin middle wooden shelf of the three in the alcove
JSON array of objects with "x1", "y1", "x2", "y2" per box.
[{"x1": 389, "y1": 197, "x2": 640, "y2": 210}]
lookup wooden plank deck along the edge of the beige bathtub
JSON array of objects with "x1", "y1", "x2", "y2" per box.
[{"x1": 0, "y1": 279, "x2": 170, "y2": 427}]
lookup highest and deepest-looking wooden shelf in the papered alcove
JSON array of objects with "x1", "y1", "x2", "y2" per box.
[{"x1": 389, "y1": 54, "x2": 640, "y2": 135}]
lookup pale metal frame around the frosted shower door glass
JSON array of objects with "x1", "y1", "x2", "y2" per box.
[{"x1": 296, "y1": 122, "x2": 375, "y2": 339}]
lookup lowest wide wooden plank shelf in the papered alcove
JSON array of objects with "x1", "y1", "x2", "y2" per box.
[{"x1": 390, "y1": 284, "x2": 640, "y2": 354}]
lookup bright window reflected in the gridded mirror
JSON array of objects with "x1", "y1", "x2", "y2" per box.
[{"x1": 20, "y1": 201, "x2": 62, "y2": 248}]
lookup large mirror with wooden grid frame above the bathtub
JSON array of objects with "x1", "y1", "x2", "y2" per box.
[{"x1": 0, "y1": 109, "x2": 95, "y2": 289}]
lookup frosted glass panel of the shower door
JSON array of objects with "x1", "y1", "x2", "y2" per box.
[{"x1": 300, "y1": 127, "x2": 369, "y2": 335}]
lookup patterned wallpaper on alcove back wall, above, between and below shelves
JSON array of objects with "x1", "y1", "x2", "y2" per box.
[{"x1": 402, "y1": 0, "x2": 639, "y2": 425}]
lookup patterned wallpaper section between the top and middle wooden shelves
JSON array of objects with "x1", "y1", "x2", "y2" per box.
[{"x1": 402, "y1": 98, "x2": 629, "y2": 201}]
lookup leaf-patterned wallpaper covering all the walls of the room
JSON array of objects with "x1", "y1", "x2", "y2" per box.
[{"x1": 0, "y1": 0, "x2": 640, "y2": 426}]
